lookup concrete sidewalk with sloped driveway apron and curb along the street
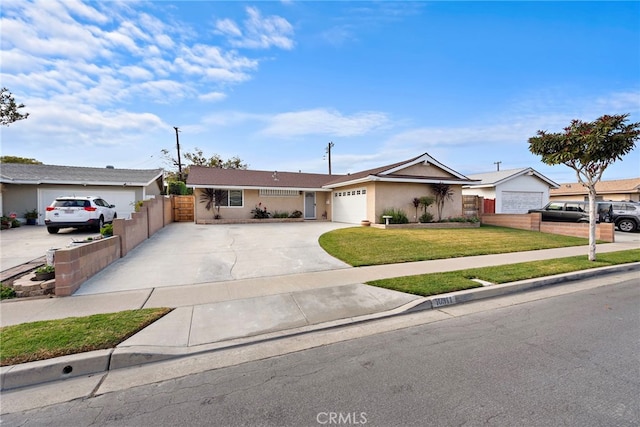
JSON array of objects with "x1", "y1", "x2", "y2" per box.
[{"x1": 0, "y1": 243, "x2": 638, "y2": 389}]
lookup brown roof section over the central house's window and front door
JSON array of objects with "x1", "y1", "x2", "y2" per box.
[{"x1": 187, "y1": 166, "x2": 336, "y2": 191}]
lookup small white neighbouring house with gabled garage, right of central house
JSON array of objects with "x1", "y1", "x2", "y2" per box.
[{"x1": 462, "y1": 168, "x2": 558, "y2": 214}]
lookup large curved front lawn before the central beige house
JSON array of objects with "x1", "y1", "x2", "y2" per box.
[{"x1": 319, "y1": 226, "x2": 589, "y2": 267}]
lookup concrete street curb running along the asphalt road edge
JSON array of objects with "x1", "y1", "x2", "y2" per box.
[{"x1": 0, "y1": 262, "x2": 640, "y2": 391}]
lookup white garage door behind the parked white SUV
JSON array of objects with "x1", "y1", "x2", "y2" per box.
[{"x1": 38, "y1": 187, "x2": 136, "y2": 224}]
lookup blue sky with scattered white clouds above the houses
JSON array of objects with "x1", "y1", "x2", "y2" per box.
[{"x1": 0, "y1": 0, "x2": 640, "y2": 183}]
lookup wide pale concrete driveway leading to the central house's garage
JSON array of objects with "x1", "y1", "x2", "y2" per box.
[{"x1": 74, "y1": 222, "x2": 352, "y2": 295}]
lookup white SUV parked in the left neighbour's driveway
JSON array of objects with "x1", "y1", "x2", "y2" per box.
[{"x1": 44, "y1": 196, "x2": 117, "y2": 234}]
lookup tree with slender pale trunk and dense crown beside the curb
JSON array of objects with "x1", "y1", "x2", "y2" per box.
[{"x1": 529, "y1": 114, "x2": 640, "y2": 261}]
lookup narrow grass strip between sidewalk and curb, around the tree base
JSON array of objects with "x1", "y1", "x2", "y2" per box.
[{"x1": 367, "y1": 249, "x2": 640, "y2": 296}]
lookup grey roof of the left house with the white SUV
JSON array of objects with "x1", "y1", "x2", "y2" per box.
[{"x1": 0, "y1": 163, "x2": 164, "y2": 187}]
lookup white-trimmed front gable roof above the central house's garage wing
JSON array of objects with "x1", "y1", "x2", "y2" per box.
[{"x1": 325, "y1": 153, "x2": 472, "y2": 188}]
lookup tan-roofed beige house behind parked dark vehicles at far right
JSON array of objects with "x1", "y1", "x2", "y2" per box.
[{"x1": 549, "y1": 178, "x2": 640, "y2": 202}]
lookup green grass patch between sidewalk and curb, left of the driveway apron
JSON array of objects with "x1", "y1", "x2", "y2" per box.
[{"x1": 0, "y1": 308, "x2": 171, "y2": 366}]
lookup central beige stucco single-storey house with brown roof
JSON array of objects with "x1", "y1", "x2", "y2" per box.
[{"x1": 187, "y1": 153, "x2": 475, "y2": 224}]
